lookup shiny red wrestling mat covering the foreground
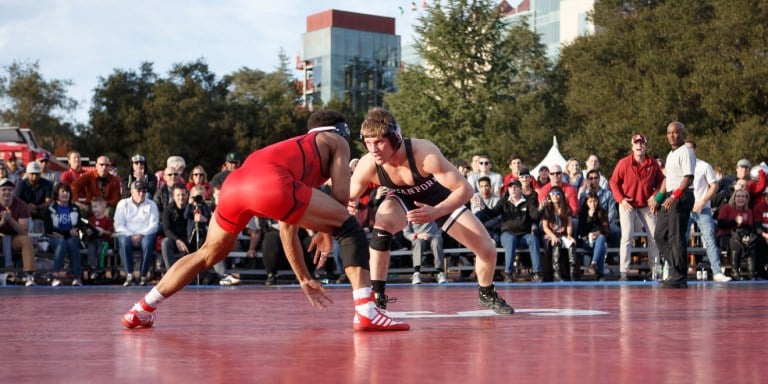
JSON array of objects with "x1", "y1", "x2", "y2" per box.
[{"x1": 0, "y1": 282, "x2": 768, "y2": 384}]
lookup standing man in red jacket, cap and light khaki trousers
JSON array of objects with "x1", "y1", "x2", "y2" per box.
[{"x1": 609, "y1": 134, "x2": 664, "y2": 281}]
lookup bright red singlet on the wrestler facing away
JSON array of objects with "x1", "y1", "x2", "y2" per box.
[{"x1": 216, "y1": 127, "x2": 333, "y2": 233}]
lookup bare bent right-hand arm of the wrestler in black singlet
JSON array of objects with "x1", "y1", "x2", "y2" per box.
[{"x1": 412, "y1": 139, "x2": 473, "y2": 219}]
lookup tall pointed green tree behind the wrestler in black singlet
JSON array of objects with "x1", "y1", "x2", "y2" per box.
[{"x1": 385, "y1": 0, "x2": 558, "y2": 164}]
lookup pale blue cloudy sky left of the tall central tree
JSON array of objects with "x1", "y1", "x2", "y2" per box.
[{"x1": 0, "y1": 0, "x2": 433, "y2": 124}]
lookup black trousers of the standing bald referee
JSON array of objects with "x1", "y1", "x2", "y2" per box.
[{"x1": 653, "y1": 189, "x2": 694, "y2": 282}]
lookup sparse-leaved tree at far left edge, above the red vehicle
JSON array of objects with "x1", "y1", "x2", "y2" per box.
[{"x1": 0, "y1": 61, "x2": 77, "y2": 150}]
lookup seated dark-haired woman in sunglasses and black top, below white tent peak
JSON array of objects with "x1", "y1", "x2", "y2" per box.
[{"x1": 541, "y1": 186, "x2": 581, "y2": 281}]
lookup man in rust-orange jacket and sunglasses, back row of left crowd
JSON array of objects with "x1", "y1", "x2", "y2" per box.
[{"x1": 71, "y1": 156, "x2": 120, "y2": 216}]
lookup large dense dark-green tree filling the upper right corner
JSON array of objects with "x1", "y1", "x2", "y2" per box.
[{"x1": 561, "y1": 0, "x2": 768, "y2": 169}]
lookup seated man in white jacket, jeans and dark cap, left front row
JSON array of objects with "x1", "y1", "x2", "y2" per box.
[{"x1": 114, "y1": 181, "x2": 160, "y2": 286}]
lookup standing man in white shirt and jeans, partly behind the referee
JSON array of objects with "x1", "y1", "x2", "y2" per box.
[{"x1": 685, "y1": 140, "x2": 731, "y2": 283}]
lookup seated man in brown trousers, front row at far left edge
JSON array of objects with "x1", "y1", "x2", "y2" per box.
[{"x1": 0, "y1": 178, "x2": 35, "y2": 286}]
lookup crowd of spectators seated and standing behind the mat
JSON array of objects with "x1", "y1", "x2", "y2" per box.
[{"x1": 0, "y1": 134, "x2": 768, "y2": 286}]
